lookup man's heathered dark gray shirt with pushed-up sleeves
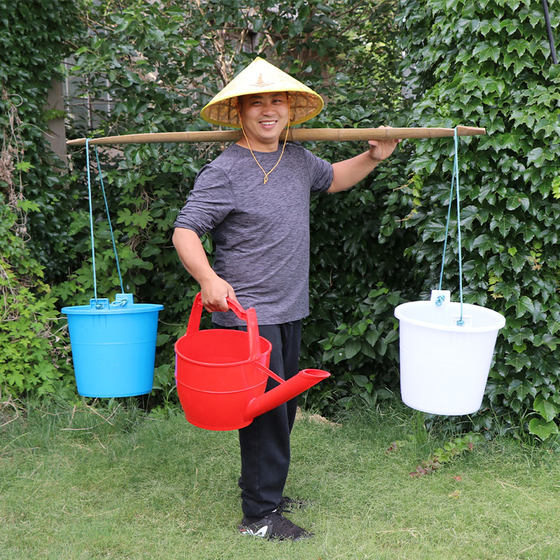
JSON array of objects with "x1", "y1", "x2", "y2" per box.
[{"x1": 175, "y1": 142, "x2": 333, "y2": 326}]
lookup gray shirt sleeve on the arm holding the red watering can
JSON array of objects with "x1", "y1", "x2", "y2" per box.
[{"x1": 174, "y1": 164, "x2": 234, "y2": 237}]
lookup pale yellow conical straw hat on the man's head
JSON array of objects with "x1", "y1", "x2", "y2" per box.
[{"x1": 200, "y1": 57, "x2": 324, "y2": 128}]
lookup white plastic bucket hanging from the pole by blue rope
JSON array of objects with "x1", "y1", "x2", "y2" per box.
[{"x1": 395, "y1": 298, "x2": 506, "y2": 416}]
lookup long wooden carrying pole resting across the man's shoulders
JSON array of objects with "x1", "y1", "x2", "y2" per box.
[{"x1": 66, "y1": 126, "x2": 486, "y2": 146}]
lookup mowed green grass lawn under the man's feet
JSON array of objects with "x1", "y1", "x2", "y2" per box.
[{"x1": 0, "y1": 402, "x2": 560, "y2": 560}]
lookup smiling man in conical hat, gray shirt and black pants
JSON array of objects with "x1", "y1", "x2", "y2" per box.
[{"x1": 173, "y1": 58, "x2": 397, "y2": 540}]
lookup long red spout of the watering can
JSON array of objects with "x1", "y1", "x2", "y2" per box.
[{"x1": 245, "y1": 364, "x2": 330, "y2": 420}]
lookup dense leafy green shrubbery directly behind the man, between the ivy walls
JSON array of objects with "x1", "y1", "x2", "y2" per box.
[{"x1": 61, "y1": 0, "x2": 414, "y2": 411}]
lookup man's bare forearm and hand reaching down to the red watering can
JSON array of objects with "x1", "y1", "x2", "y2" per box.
[{"x1": 173, "y1": 228, "x2": 237, "y2": 312}]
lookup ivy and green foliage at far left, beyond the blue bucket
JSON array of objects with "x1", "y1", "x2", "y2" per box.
[{"x1": 0, "y1": 0, "x2": 83, "y2": 395}]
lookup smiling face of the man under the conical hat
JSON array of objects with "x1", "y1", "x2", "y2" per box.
[{"x1": 239, "y1": 91, "x2": 289, "y2": 151}]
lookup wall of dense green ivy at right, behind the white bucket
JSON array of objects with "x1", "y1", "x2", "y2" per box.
[{"x1": 400, "y1": 0, "x2": 560, "y2": 438}]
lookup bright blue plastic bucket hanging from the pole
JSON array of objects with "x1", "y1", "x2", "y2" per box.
[{"x1": 62, "y1": 294, "x2": 163, "y2": 398}]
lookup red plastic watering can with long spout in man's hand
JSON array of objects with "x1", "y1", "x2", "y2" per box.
[{"x1": 175, "y1": 293, "x2": 330, "y2": 430}]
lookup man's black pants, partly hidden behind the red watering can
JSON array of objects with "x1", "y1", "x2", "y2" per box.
[{"x1": 228, "y1": 321, "x2": 301, "y2": 518}]
